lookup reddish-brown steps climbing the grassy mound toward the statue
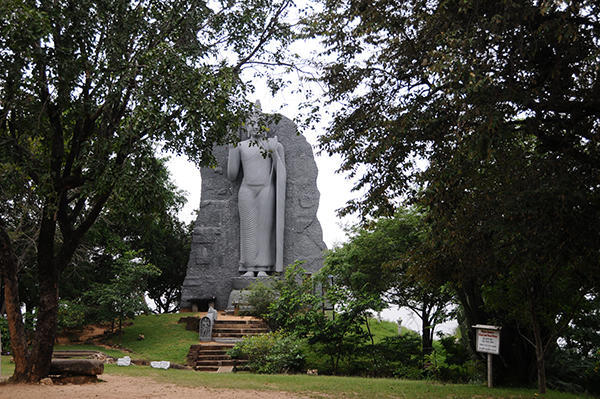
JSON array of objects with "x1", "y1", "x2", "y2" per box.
[{"x1": 186, "y1": 316, "x2": 269, "y2": 372}]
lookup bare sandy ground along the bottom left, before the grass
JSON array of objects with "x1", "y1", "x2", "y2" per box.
[{"x1": 0, "y1": 374, "x2": 308, "y2": 399}]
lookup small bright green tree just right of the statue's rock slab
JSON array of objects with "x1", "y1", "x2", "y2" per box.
[{"x1": 325, "y1": 209, "x2": 453, "y2": 354}]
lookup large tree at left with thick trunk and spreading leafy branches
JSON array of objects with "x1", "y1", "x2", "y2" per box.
[{"x1": 0, "y1": 0, "x2": 291, "y2": 381}]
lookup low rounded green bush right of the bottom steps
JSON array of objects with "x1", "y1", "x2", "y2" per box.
[{"x1": 228, "y1": 332, "x2": 305, "y2": 374}]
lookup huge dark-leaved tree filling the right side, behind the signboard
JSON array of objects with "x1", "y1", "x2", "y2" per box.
[{"x1": 309, "y1": 0, "x2": 600, "y2": 391}]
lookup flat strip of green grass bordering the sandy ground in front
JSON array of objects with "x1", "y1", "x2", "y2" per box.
[{"x1": 105, "y1": 365, "x2": 588, "y2": 399}]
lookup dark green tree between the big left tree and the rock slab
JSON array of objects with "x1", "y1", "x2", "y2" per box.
[{"x1": 60, "y1": 156, "x2": 191, "y2": 312}]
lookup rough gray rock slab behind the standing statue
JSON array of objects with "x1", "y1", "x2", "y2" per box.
[{"x1": 181, "y1": 117, "x2": 326, "y2": 310}]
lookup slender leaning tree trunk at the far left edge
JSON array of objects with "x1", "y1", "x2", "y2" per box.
[{"x1": 0, "y1": 226, "x2": 29, "y2": 382}]
